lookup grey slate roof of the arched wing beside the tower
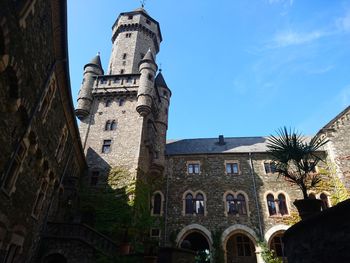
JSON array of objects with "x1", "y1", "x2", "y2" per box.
[{"x1": 166, "y1": 136, "x2": 318, "y2": 155}]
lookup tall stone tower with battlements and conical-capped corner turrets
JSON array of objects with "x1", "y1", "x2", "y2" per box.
[{"x1": 75, "y1": 8, "x2": 171, "y2": 184}]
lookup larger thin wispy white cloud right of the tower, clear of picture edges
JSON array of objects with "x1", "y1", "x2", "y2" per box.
[{"x1": 268, "y1": 30, "x2": 328, "y2": 48}]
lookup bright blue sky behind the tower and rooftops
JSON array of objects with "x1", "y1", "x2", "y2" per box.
[{"x1": 68, "y1": 0, "x2": 350, "y2": 139}]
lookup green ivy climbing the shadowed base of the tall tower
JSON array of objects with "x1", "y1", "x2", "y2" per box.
[{"x1": 81, "y1": 167, "x2": 153, "y2": 245}]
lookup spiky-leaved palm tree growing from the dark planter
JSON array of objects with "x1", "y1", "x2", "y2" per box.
[{"x1": 267, "y1": 127, "x2": 328, "y2": 199}]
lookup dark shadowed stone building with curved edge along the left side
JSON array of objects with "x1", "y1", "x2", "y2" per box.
[{"x1": 0, "y1": 0, "x2": 86, "y2": 263}]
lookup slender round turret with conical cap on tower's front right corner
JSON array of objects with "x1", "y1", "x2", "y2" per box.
[{"x1": 136, "y1": 49, "x2": 158, "y2": 116}]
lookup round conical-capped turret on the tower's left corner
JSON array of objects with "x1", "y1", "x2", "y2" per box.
[{"x1": 75, "y1": 54, "x2": 103, "y2": 120}]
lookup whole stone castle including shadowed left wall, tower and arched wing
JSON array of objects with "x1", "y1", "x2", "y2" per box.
[{"x1": 0, "y1": 0, "x2": 350, "y2": 263}]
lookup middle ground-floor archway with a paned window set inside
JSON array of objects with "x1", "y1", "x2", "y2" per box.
[{"x1": 226, "y1": 233, "x2": 256, "y2": 263}]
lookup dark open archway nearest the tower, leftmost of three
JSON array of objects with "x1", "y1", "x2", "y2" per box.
[{"x1": 180, "y1": 231, "x2": 210, "y2": 263}]
